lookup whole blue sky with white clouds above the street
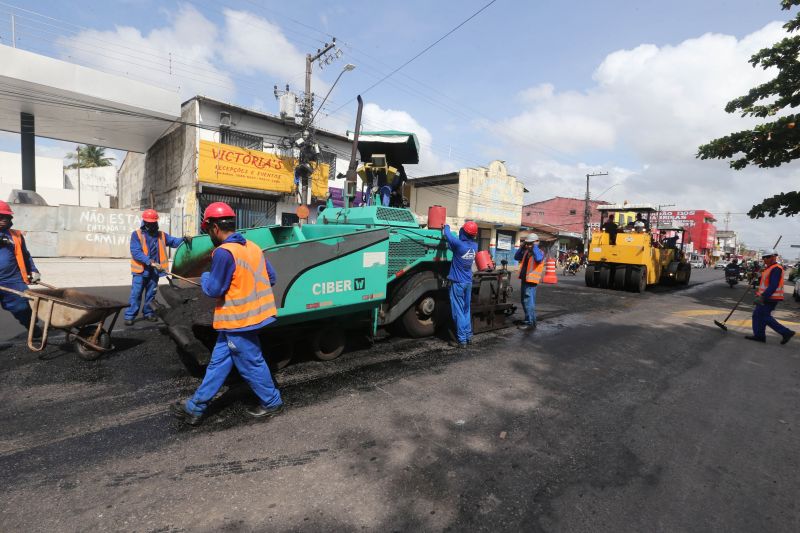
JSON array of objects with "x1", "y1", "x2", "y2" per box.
[{"x1": 0, "y1": 0, "x2": 800, "y2": 254}]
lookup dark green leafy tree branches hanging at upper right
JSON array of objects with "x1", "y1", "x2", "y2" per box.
[{"x1": 697, "y1": 0, "x2": 800, "y2": 218}]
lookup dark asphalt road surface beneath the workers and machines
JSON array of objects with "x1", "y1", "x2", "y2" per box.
[{"x1": 0, "y1": 271, "x2": 800, "y2": 532}]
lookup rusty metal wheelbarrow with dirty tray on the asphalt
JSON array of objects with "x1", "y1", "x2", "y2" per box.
[{"x1": 0, "y1": 282, "x2": 128, "y2": 361}]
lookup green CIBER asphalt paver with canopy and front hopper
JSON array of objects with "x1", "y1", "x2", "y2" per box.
[{"x1": 158, "y1": 96, "x2": 514, "y2": 370}]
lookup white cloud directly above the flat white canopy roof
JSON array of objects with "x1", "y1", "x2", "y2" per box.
[{"x1": 57, "y1": 4, "x2": 231, "y2": 100}]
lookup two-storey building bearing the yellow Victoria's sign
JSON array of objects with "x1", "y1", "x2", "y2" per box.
[{"x1": 119, "y1": 96, "x2": 351, "y2": 235}]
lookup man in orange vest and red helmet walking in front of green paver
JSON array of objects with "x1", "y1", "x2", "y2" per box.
[{"x1": 173, "y1": 202, "x2": 283, "y2": 426}]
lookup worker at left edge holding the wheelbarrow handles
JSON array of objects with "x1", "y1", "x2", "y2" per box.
[{"x1": 0, "y1": 201, "x2": 42, "y2": 338}]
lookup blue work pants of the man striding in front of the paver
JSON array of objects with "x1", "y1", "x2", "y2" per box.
[{"x1": 186, "y1": 331, "x2": 283, "y2": 415}]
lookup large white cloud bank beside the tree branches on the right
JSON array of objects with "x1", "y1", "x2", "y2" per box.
[{"x1": 486, "y1": 22, "x2": 800, "y2": 258}]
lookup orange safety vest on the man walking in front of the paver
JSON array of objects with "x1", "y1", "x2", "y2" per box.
[{"x1": 212, "y1": 241, "x2": 278, "y2": 330}]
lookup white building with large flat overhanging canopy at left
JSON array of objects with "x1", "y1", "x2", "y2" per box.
[{"x1": 0, "y1": 45, "x2": 180, "y2": 207}]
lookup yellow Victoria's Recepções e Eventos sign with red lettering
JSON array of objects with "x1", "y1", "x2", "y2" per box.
[{"x1": 198, "y1": 141, "x2": 329, "y2": 198}]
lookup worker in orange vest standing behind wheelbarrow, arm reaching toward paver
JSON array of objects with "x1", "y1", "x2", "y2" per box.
[{"x1": 125, "y1": 209, "x2": 191, "y2": 326}]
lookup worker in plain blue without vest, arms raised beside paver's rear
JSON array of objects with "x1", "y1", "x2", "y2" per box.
[{"x1": 442, "y1": 220, "x2": 478, "y2": 348}]
